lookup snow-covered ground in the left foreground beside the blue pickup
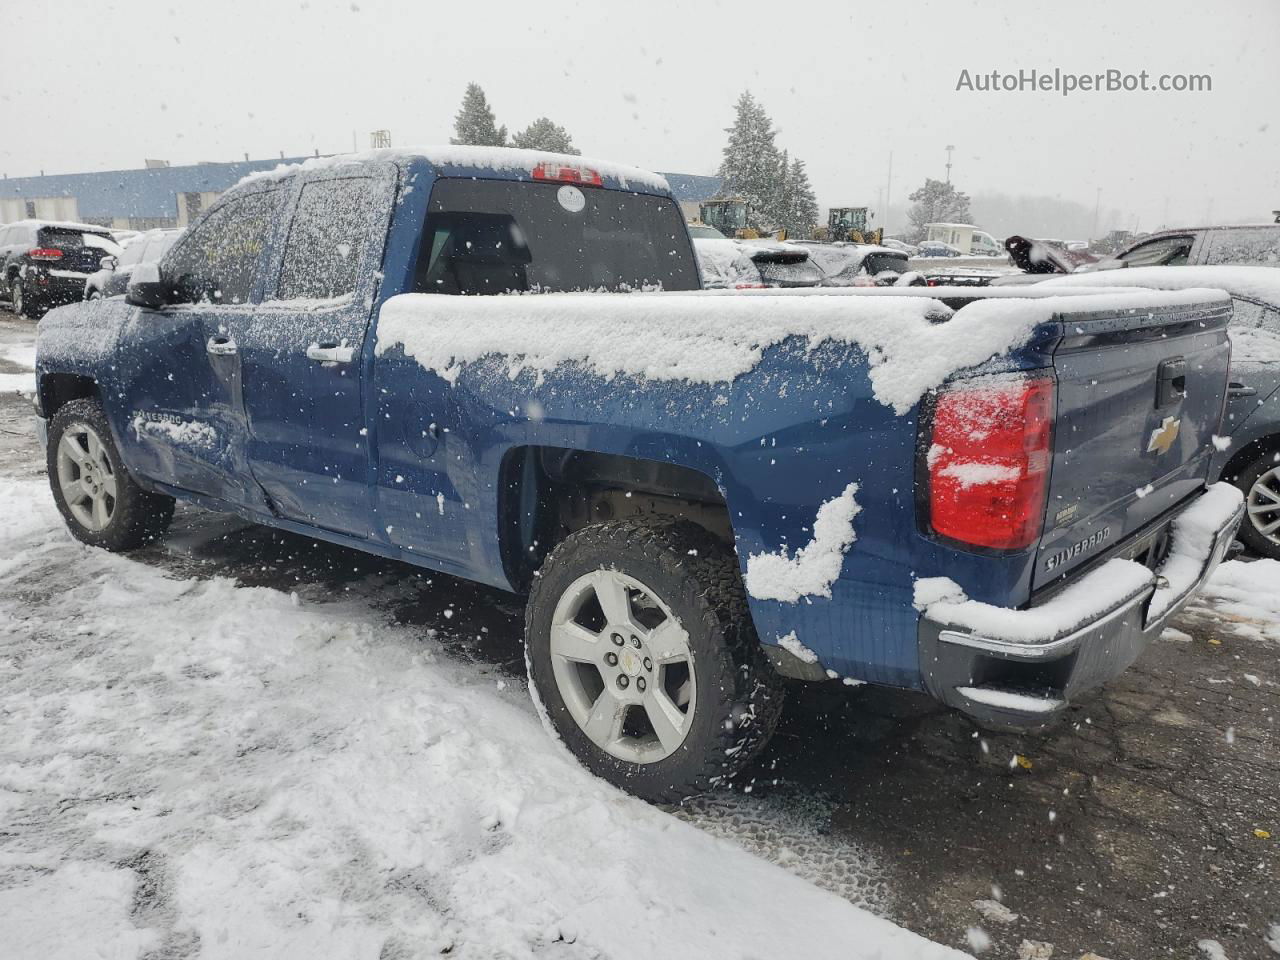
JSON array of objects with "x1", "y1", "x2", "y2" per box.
[{"x1": 0, "y1": 479, "x2": 960, "y2": 960}]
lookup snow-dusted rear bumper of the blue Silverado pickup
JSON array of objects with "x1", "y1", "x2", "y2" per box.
[{"x1": 919, "y1": 484, "x2": 1244, "y2": 728}]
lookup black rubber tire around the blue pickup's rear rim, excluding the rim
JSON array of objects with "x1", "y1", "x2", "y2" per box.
[{"x1": 525, "y1": 517, "x2": 785, "y2": 803}]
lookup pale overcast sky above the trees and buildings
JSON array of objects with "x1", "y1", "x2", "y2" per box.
[{"x1": 0, "y1": 0, "x2": 1280, "y2": 229}]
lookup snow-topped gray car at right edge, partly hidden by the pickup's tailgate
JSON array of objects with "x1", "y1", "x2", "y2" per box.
[{"x1": 1043, "y1": 266, "x2": 1280, "y2": 559}]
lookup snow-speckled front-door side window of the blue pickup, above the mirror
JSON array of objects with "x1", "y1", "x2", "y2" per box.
[{"x1": 164, "y1": 189, "x2": 280, "y2": 303}]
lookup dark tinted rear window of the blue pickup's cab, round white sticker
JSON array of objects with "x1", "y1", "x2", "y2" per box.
[{"x1": 413, "y1": 179, "x2": 699, "y2": 294}]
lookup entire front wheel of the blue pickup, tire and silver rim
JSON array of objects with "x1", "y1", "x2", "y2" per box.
[{"x1": 46, "y1": 399, "x2": 174, "y2": 552}]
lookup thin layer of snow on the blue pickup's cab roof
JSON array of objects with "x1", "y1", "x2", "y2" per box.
[{"x1": 236, "y1": 145, "x2": 671, "y2": 193}]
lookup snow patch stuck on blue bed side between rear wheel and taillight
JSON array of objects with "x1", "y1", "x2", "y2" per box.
[{"x1": 744, "y1": 484, "x2": 863, "y2": 604}]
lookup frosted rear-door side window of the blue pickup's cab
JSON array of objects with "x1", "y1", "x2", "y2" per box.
[{"x1": 275, "y1": 177, "x2": 378, "y2": 300}]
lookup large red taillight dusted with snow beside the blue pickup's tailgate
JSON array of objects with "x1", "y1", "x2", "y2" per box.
[{"x1": 928, "y1": 378, "x2": 1053, "y2": 549}]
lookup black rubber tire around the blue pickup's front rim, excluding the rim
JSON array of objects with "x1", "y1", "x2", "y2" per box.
[{"x1": 45, "y1": 398, "x2": 174, "y2": 553}]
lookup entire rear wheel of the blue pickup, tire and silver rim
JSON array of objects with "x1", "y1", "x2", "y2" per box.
[{"x1": 525, "y1": 518, "x2": 783, "y2": 803}]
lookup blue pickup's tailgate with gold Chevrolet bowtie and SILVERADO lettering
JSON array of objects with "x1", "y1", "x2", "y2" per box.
[{"x1": 1032, "y1": 295, "x2": 1231, "y2": 590}]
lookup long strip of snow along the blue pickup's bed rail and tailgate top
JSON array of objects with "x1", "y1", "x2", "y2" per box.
[{"x1": 378, "y1": 288, "x2": 1224, "y2": 415}]
